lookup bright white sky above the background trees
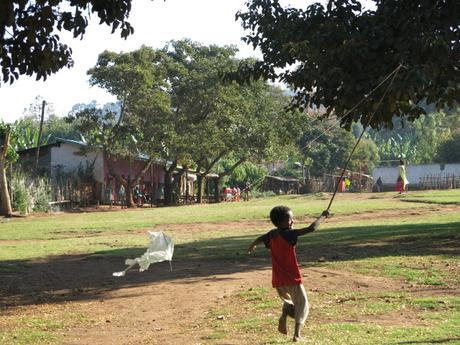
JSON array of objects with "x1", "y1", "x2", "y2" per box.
[{"x1": 0, "y1": 0, "x2": 372, "y2": 122}]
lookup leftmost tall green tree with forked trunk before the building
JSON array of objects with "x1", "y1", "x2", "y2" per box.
[{"x1": 69, "y1": 47, "x2": 171, "y2": 207}]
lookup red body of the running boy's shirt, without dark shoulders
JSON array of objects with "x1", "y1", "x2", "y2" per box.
[{"x1": 270, "y1": 234, "x2": 302, "y2": 288}]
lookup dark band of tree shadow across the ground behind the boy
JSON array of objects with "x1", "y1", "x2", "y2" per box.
[{"x1": 0, "y1": 222, "x2": 460, "y2": 310}]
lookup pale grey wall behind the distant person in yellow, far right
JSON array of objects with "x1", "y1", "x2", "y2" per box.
[{"x1": 372, "y1": 163, "x2": 460, "y2": 187}]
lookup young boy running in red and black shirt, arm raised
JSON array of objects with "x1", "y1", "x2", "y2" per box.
[{"x1": 248, "y1": 206, "x2": 329, "y2": 341}]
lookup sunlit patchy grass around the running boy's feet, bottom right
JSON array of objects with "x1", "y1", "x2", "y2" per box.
[{"x1": 208, "y1": 290, "x2": 460, "y2": 345}]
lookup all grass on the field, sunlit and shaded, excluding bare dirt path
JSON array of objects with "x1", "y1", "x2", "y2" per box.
[{"x1": 0, "y1": 191, "x2": 460, "y2": 345}]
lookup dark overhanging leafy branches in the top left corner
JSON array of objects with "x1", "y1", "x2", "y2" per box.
[{"x1": 0, "y1": 0, "x2": 134, "y2": 84}]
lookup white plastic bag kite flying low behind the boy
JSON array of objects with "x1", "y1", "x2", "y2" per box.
[{"x1": 113, "y1": 231, "x2": 174, "y2": 277}]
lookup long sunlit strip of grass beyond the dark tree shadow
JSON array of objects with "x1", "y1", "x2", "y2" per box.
[{"x1": 0, "y1": 195, "x2": 434, "y2": 240}]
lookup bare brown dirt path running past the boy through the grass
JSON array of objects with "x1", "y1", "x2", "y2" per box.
[{"x1": 54, "y1": 263, "x2": 460, "y2": 345}]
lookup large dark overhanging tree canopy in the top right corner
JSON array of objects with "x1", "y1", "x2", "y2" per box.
[{"x1": 237, "y1": 0, "x2": 460, "y2": 127}]
